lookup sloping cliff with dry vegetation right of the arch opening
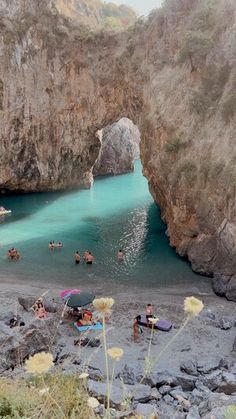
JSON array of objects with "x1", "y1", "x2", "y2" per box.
[{"x1": 135, "y1": 0, "x2": 236, "y2": 301}]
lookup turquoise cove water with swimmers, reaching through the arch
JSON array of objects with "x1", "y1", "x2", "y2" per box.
[{"x1": 0, "y1": 161, "x2": 201, "y2": 286}]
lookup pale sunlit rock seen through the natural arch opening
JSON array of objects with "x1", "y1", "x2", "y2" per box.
[{"x1": 93, "y1": 118, "x2": 140, "y2": 176}]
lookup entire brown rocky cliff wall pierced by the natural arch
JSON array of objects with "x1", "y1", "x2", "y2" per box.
[{"x1": 0, "y1": 0, "x2": 236, "y2": 300}]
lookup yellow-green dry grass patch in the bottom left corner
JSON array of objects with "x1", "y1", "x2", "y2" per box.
[{"x1": 0, "y1": 374, "x2": 95, "y2": 419}]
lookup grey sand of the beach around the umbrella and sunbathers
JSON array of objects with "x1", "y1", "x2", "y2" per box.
[{"x1": 0, "y1": 277, "x2": 235, "y2": 380}]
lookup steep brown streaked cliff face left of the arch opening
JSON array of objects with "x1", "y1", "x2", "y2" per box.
[{"x1": 0, "y1": 0, "x2": 140, "y2": 191}]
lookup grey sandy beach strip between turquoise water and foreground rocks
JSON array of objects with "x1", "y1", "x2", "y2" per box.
[{"x1": 0, "y1": 277, "x2": 235, "y2": 369}]
